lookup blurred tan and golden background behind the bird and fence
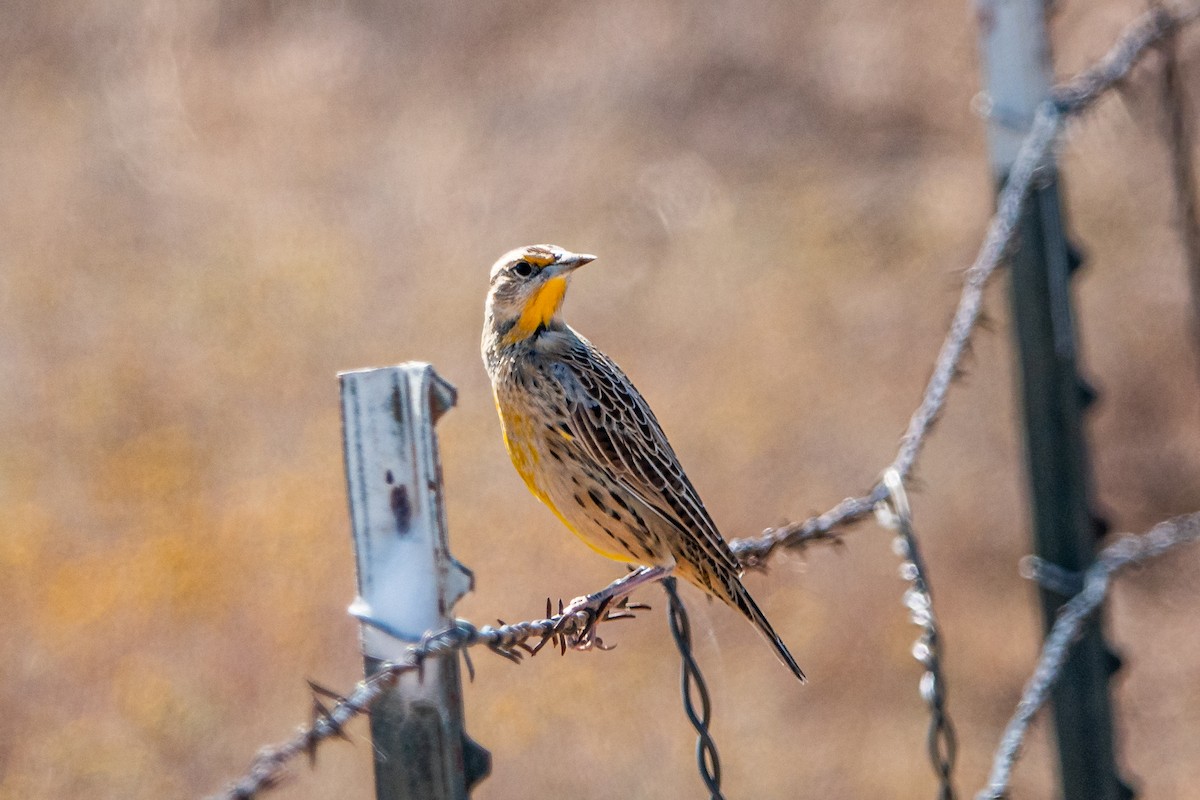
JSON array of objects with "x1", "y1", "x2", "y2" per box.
[{"x1": 0, "y1": 0, "x2": 1200, "y2": 800}]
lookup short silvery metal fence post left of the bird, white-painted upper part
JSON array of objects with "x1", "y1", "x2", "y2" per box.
[{"x1": 340, "y1": 363, "x2": 490, "y2": 800}]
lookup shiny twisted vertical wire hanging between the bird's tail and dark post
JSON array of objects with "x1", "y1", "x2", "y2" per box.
[{"x1": 875, "y1": 468, "x2": 958, "y2": 800}]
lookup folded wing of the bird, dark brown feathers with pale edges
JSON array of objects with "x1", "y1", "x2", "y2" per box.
[{"x1": 552, "y1": 337, "x2": 742, "y2": 575}]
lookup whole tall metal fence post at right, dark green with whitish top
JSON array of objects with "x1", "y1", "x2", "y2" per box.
[{"x1": 978, "y1": 0, "x2": 1133, "y2": 800}]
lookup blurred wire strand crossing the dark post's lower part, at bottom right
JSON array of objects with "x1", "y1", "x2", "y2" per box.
[{"x1": 976, "y1": 512, "x2": 1200, "y2": 800}]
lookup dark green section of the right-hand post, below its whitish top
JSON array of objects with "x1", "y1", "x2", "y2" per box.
[{"x1": 1010, "y1": 179, "x2": 1133, "y2": 800}]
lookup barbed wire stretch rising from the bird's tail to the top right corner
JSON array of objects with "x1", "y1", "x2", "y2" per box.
[{"x1": 730, "y1": 8, "x2": 1200, "y2": 569}]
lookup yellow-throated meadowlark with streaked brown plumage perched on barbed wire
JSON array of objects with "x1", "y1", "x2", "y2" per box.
[{"x1": 482, "y1": 245, "x2": 804, "y2": 681}]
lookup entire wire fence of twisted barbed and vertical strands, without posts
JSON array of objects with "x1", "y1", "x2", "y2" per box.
[{"x1": 212, "y1": 7, "x2": 1200, "y2": 800}]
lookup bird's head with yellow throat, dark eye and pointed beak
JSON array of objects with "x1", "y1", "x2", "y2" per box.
[{"x1": 484, "y1": 245, "x2": 595, "y2": 347}]
